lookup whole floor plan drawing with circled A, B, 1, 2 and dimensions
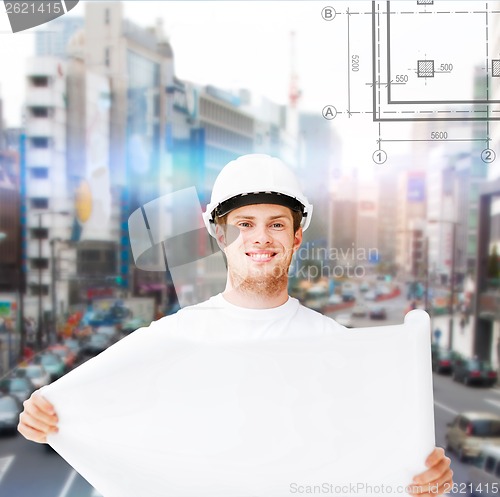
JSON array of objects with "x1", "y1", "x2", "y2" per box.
[{"x1": 324, "y1": 0, "x2": 500, "y2": 164}]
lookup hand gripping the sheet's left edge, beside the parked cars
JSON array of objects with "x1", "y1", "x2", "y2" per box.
[{"x1": 17, "y1": 390, "x2": 59, "y2": 443}]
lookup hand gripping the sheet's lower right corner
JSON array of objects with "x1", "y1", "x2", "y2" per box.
[{"x1": 409, "y1": 447, "x2": 453, "y2": 497}]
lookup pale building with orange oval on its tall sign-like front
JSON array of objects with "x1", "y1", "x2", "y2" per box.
[{"x1": 66, "y1": 29, "x2": 120, "y2": 305}]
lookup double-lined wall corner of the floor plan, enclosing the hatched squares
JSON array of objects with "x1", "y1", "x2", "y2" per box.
[{"x1": 372, "y1": 1, "x2": 500, "y2": 121}]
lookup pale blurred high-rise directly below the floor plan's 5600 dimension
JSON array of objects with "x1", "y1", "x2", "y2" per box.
[{"x1": 412, "y1": 103, "x2": 486, "y2": 294}]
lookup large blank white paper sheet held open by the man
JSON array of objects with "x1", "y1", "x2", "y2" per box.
[{"x1": 43, "y1": 311, "x2": 435, "y2": 497}]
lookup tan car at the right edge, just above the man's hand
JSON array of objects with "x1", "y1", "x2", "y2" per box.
[{"x1": 445, "y1": 411, "x2": 500, "y2": 461}]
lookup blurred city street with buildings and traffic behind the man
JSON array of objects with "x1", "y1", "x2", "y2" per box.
[{"x1": 0, "y1": 1, "x2": 500, "y2": 497}]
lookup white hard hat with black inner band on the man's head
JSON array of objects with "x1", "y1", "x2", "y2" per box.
[{"x1": 203, "y1": 154, "x2": 312, "y2": 237}]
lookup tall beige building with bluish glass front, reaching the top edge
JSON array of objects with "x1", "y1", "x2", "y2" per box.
[{"x1": 82, "y1": 2, "x2": 173, "y2": 304}]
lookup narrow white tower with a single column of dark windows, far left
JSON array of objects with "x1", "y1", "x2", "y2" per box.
[{"x1": 21, "y1": 56, "x2": 73, "y2": 333}]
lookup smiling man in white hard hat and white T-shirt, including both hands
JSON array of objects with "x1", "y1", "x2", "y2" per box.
[{"x1": 18, "y1": 154, "x2": 452, "y2": 496}]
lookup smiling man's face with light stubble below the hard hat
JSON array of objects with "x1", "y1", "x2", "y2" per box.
[{"x1": 217, "y1": 204, "x2": 302, "y2": 295}]
